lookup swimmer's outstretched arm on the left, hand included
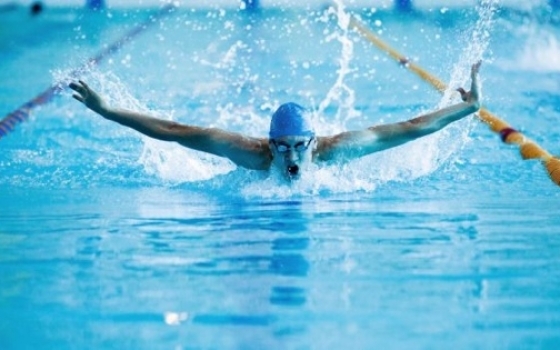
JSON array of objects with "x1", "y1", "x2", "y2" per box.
[{"x1": 69, "y1": 81, "x2": 272, "y2": 170}]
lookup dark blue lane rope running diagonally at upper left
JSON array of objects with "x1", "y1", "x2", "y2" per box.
[{"x1": 0, "y1": 4, "x2": 176, "y2": 139}]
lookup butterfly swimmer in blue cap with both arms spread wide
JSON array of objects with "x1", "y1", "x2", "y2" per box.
[{"x1": 70, "y1": 62, "x2": 480, "y2": 181}]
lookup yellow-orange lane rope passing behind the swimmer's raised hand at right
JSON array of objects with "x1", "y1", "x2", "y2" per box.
[{"x1": 348, "y1": 16, "x2": 560, "y2": 186}]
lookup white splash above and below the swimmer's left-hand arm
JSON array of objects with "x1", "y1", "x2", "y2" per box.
[{"x1": 54, "y1": 67, "x2": 235, "y2": 183}]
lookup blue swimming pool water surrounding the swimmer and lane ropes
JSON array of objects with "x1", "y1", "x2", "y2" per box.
[{"x1": 0, "y1": 1, "x2": 560, "y2": 349}]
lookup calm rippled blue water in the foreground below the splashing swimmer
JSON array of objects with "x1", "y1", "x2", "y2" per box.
[{"x1": 0, "y1": 186, "x2": 560, "y2": 349}]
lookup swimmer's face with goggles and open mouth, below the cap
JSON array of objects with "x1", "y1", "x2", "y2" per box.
[{"x1": 270, "y1": 136, "x2": 317, "y2": 180}]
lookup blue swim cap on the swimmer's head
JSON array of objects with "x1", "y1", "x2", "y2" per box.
[{"x1": 269, "y1": 102, "x2": 315, "y2": 139}]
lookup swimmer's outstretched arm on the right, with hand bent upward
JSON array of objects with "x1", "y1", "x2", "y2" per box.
[{"x1": 316, "y1": 62, "x2": 481, "y2": 161}]
